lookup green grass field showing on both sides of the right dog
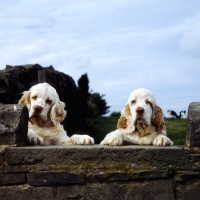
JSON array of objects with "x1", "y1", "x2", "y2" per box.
[{"x1": 90, "y1": 116, "x2": 186, "y2": 145}]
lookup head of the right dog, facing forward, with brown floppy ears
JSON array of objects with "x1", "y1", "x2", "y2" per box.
[{"x1": 117, "y1": 88, "x2": 166, "y2": 134}]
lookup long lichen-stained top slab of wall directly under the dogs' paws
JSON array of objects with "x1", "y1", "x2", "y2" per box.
[{"x1": 3, "y1": 145, "x2": 200, "y2": 173}]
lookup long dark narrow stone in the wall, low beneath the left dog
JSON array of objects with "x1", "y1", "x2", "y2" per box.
[{"x1": 26, "y1": 172, "x2": 84, "y2": 186}]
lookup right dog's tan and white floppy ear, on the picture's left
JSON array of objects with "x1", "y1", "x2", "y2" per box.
[{"x1": 117, "y1": 104, "x2": 135, "y2": 132}]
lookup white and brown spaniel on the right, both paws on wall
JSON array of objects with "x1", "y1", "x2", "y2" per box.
[{"x1": 100, "y1": 88, "x2": 173, "y2": 146}]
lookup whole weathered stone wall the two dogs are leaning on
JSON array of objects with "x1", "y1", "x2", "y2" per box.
[{"x1": 0, "y1": 103, "x2": 200, "y2": 200}]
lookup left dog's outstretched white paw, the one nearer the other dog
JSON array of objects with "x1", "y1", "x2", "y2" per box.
[{"x1": 70, "y1": 135, "x2": 94, "y2": 145}]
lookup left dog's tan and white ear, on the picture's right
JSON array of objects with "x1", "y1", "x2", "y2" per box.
[{"x1": 50, "y1": 101, "x2": 66, "y2": 126}]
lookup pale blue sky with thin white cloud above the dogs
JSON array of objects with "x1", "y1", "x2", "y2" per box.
[{"x1": 0, "y1": 0, "x2": 200, "y2": 115}]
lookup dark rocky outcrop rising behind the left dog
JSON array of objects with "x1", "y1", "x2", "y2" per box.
[{"x1": 0, "y1": 64, "x2": 87, "y2": 136}]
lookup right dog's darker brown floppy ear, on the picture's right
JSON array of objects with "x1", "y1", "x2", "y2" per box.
[{"x1": 151, "y1": 105, "x2": 166, "y2": 134}]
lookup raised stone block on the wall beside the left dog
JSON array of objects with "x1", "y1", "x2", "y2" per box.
[{"x1": 0, "y1": 104, "x2": 28, "y2": 146}]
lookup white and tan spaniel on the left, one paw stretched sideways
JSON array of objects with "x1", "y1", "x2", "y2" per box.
[{"x1": 19, "y1": 83, "x2": 94, "y2": 145}]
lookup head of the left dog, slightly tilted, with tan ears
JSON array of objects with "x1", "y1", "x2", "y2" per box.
[{"x1": 19, "y1": 83, "x2": 66, "y2": 126}]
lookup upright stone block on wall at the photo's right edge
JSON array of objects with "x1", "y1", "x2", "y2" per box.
[{"x1": 186, "y1": 102, "x2": 200, "y2": 147}]
